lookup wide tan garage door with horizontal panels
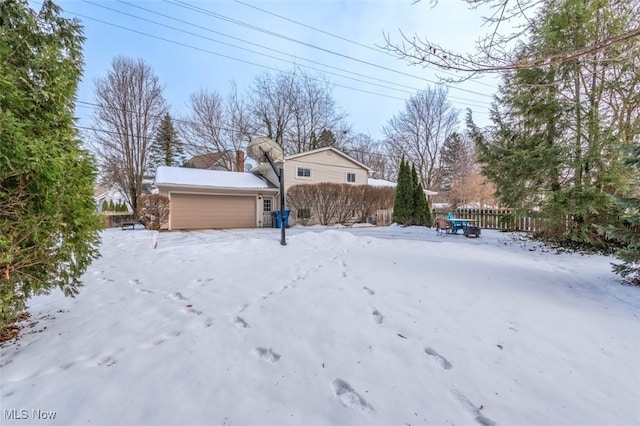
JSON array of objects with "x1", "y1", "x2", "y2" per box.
[{"x1": 171, "y1": 194, "x2": 256, "y2": 229}]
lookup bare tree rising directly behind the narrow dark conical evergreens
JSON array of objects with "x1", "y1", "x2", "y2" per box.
[{"x1": 383, "y1": 88, "x2": 458, "y2": 189}]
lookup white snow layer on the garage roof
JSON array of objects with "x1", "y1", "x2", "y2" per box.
[{"x1": 156, "y1": 166, "x2": 272, "y2": 189}]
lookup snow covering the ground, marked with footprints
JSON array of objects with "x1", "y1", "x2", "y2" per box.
[{"x1": 0, "y1": 226, "x2": 640, "y2": 425}]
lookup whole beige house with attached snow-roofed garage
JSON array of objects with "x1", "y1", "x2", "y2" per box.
[{"x1": 156, "y1": 147, "x2": 432, "y2": 230}]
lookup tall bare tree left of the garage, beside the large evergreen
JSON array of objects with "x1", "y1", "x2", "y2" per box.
[{"x1": 94, "y1": 56, "x2": 168, "y2": 214}]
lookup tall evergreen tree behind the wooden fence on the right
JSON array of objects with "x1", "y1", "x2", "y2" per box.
[{"x1": 467, "y1": 0, "x2": 640, "y2": 248}]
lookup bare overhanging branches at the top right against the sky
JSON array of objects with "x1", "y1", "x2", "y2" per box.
[{"x1": 385, "y1": 0, "x2": 640, "y2": 79}]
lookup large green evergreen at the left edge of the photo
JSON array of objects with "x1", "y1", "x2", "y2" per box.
[{"x1": 0, "y1": 0, "x2": 100, "y2": 334}]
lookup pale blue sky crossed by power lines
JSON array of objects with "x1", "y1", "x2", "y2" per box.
[{"x1": 31, "y1": 0, "x2": 496, "y2": 138}]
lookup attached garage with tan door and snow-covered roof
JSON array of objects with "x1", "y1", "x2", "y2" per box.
[{"x1": 156, "y1": 166, "x2": 278, "y2": 230}]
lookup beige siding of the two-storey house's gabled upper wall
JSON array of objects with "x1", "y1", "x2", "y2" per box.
[{"x1": 284, "y1": 150, "x2": 368, "y2": 192}]
